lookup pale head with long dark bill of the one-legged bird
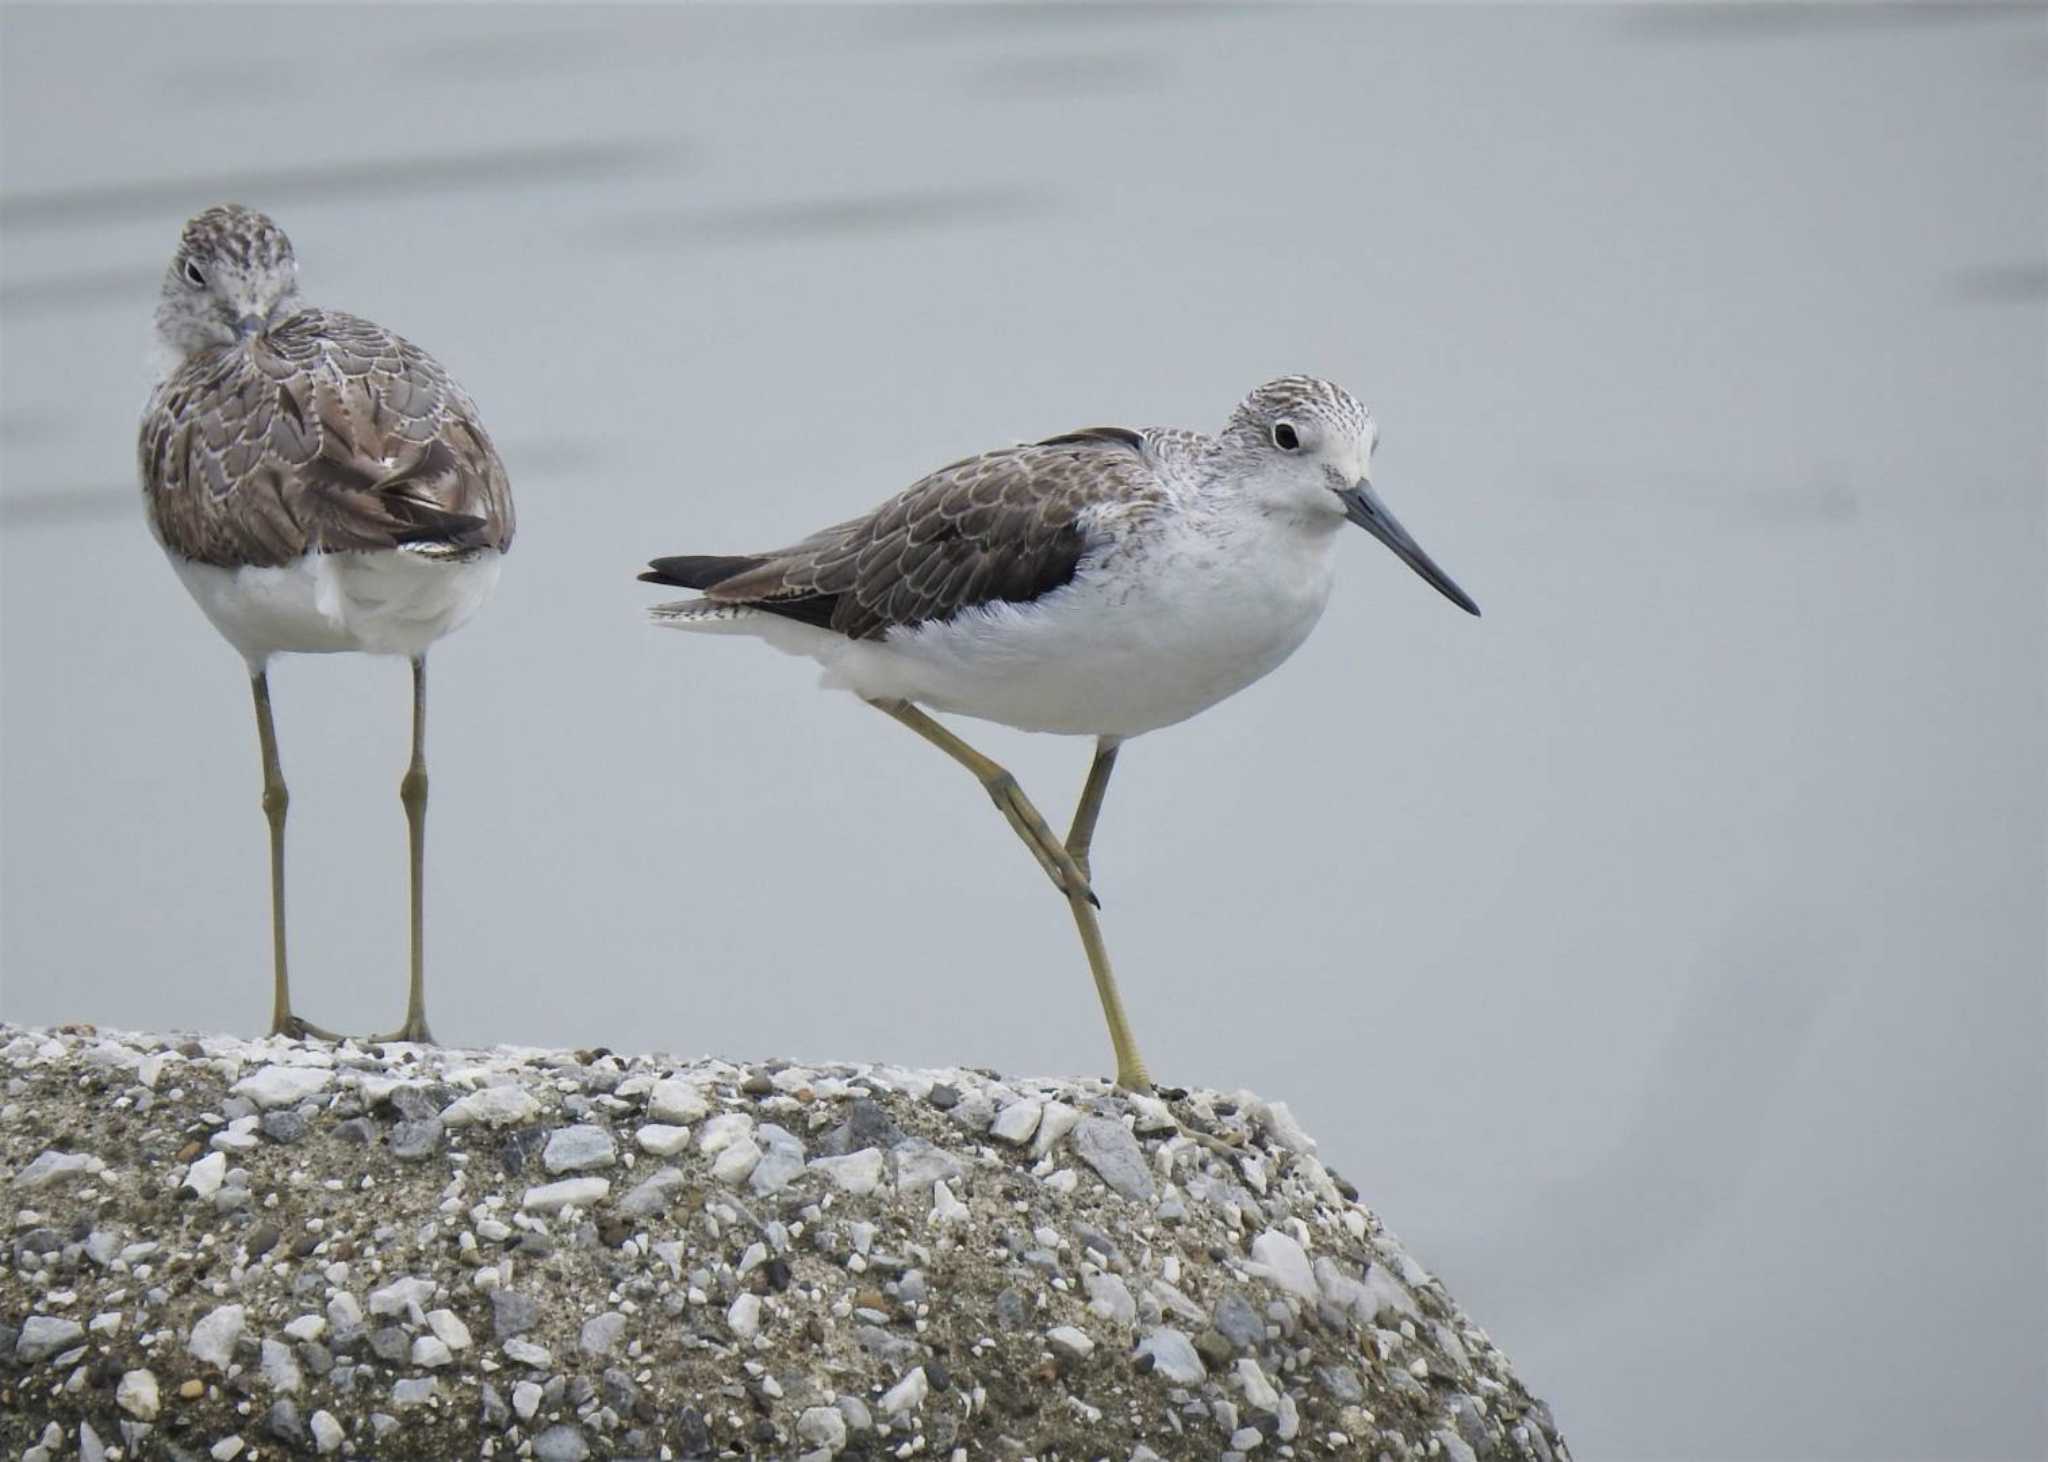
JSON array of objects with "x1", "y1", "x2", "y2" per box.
[{"x1": 1219, "y1": 375, "x2": 1479, "y2": 614}]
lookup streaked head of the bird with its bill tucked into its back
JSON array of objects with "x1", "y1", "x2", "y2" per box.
[{"x1": 156, "y1": 203, "x2": 299, "y2": 356}]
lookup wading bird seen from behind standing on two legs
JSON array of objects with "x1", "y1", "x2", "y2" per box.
[{"x1": 141, "y1": 205, "x2": 512, "y2": 1040}]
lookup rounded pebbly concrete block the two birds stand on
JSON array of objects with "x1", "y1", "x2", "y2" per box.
[{"x1": 0, "y1": 1026, "x2": 1569, "y2": 1462}]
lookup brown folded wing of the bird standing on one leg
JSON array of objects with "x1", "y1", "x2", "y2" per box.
[{"x1": 641, "y1": 428, "x2": 1163, "y2": 639}]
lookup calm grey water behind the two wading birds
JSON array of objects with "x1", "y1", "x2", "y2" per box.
[{"x1": 0, "y1": 4, "x2": 2048, "y2": 1460}]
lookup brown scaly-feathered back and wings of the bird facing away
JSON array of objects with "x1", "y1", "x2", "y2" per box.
[{"x1": 139, "y1": 309, "x2": 514, "y2": 567}]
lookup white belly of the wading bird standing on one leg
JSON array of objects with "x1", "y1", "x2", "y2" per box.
[{"x1": 825, "y1": 532, "x2": 1331, "y2": 737}]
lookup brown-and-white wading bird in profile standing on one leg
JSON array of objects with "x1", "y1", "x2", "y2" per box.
[{"x1": 641, "y1": 377, "x2": 1479, "y2": 1091}]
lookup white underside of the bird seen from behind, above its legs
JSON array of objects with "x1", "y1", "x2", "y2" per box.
[{"x1": 170, "y1": 549, "x2": 502, "y2": 665}]
